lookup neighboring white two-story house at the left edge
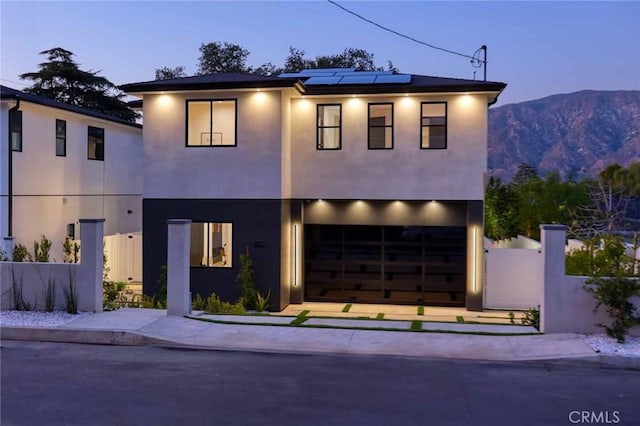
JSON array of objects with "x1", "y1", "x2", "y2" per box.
[{"x1": 0, "y1": 86, "x2": 142, "y2": 261}]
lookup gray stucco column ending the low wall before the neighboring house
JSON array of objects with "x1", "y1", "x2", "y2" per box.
[{"x1": 77, "y1": 219, "x2": 104, "y2": 312}]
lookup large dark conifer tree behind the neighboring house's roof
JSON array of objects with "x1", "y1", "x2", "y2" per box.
[{"x1": 20, "y1": 47, "x2": 138, "y2": 122}]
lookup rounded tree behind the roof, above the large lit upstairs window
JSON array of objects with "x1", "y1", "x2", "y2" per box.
[{"x1": 198, "y1": 41, "x2": 249, "y2": 75}]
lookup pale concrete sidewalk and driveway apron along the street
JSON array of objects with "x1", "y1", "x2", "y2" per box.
[{"x1": 1, "y1": 309, "x2": 639, "y2": 368}]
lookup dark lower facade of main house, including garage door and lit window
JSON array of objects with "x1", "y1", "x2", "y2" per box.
[{"x1": 143, "y1": 199, "x2": 484, "y2": 311}]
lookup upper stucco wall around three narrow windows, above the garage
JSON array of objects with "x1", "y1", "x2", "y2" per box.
[{"x1": 291, "y1": 94, "x2": 487, "y2": 200}]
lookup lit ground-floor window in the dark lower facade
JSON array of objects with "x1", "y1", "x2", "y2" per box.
[{"x1": 189, "y1": 222, "x2": 233, "y2": 268}]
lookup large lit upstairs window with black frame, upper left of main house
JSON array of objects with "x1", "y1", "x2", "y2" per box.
[{"x1": 186, "y1": 99, "x2": 237, "y2": 146}]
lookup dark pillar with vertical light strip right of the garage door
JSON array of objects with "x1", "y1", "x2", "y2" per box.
[{"x1": 465, "y1": 200, "x2": 484, "y2": 311}]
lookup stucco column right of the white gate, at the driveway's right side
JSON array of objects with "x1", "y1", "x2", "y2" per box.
[{"x1": 540, "y1": 225, "x2": 567, "y2": 333}]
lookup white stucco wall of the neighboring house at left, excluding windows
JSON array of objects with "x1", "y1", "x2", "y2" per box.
[{"x1": 3, "y1": 102, "x2": 142, "y2": 261}]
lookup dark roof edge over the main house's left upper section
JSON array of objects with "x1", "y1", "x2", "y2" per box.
[{"x1": 118, "y1": 78, "x2": 298, "y2": 93}]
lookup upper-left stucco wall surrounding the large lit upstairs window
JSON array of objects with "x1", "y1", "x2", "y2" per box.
[{"x1": 144, "y1": 90, "x2": 283, "y2": 198}]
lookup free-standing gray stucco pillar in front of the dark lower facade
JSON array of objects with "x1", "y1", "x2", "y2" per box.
[{"x1": 167, "y1": 219, "x2": 191, "y2": 316}]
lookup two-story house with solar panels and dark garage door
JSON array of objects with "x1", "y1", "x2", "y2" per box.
[{"x1": 121, "y1": 69, "x2": 505, "y2": 310}]
